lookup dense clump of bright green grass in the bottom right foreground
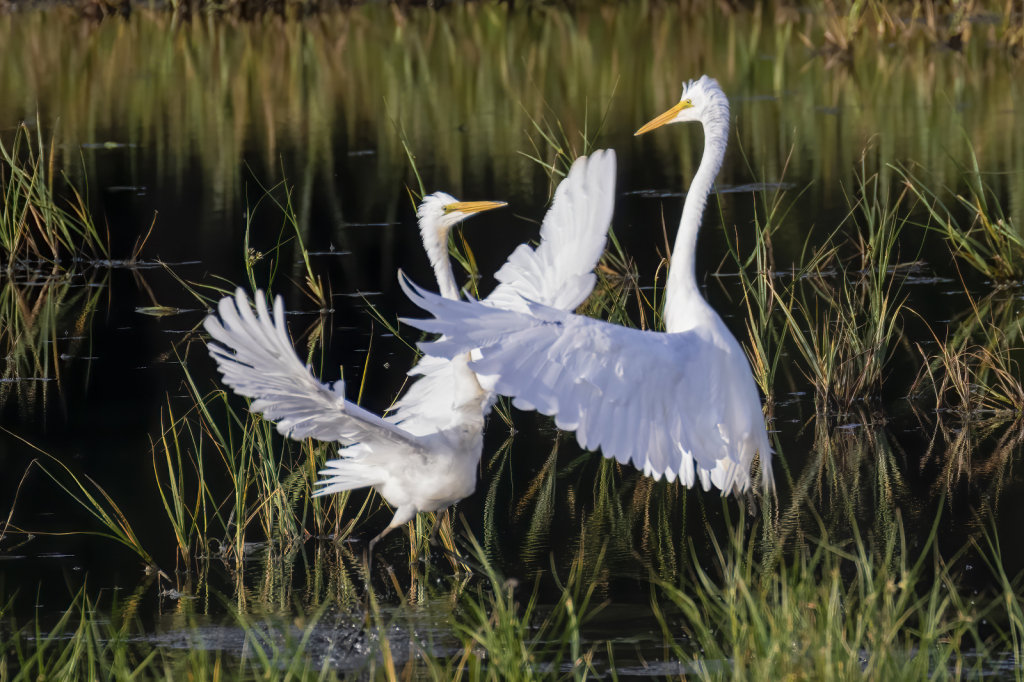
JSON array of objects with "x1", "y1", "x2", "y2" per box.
[{"x1": 652, "y1": 497, "x2": 1021, "y2": 680}]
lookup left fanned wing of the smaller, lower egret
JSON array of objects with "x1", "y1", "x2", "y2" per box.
[{"x1": 204, "y1": 289, "x2": 425, "y2": 453}]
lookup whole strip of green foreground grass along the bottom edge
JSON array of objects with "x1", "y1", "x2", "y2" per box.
[{"x1": 0, "y1": 493, "x2": 1024, "y2": 682}]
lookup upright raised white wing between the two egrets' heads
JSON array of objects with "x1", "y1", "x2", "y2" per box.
[{"x1": 483, "y1": 150, "x2": 615, "y2": 312}]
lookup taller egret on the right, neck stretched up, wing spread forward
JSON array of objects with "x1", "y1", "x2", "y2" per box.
[{"x1": 399, "y1": 76, "x2": 773, "y2": 494}]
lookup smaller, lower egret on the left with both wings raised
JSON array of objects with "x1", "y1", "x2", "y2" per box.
[{"x1": 200, "y1": 151, "x2": 615, "y2": 554}]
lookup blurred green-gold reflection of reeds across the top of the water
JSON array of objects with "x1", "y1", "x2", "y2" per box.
[{"x1": 0, "y1": 4, "x2": 1024, "y2": 262}]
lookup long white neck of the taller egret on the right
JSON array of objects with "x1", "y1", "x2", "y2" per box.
[{"x1": 665, "y1": 106, "x2": 729, "y2": 332}]
